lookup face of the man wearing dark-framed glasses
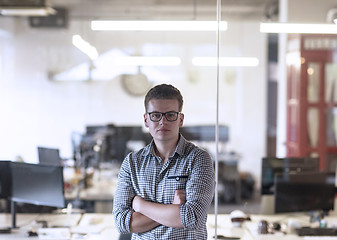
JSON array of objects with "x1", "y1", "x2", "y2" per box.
[{"x1": 144, "y1": 99, "x2": 184, "y2": 141}]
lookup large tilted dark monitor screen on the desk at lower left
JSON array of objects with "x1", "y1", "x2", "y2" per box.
[{"x1": 11, "y1": 162, "x2": 65, "y2": 208}]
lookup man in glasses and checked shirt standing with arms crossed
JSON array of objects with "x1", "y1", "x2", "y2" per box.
[{"x1": 113, "y1": 84, "x2": 215, "y2": 240}]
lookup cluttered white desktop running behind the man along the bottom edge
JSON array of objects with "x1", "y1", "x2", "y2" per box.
[{"x1": 0, "y1": 213, "x2": 337, "y2": 240}]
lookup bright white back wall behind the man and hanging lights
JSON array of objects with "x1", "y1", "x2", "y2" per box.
[{"x1": 0, "y1": 19, "x2": 267, "y2": 186}]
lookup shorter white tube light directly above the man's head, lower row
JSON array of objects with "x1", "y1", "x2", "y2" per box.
[{"x1": 114, "y1": 56, "x2": 181, "y2": 66}]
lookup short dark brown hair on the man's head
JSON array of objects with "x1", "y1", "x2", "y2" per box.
[{"x1": 144, "y1": 84, "x2": 184, "y2": 112}]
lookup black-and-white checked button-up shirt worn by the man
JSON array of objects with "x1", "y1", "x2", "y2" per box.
[{"x1": 113, "y1": 135, "x2": 215, "y2": 240}]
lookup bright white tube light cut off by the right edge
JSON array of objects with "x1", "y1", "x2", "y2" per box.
[{"x1": 260, "y1": 23, "x2": 337, "y2": 34}]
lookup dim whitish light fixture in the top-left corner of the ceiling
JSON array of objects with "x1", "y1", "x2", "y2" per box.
[{"x1": 0, "y1": 7, "x2": 56, "y2": 16}]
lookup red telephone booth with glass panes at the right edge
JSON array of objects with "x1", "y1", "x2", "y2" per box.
[{"x1": 286, "y1": 34, "x2": 337, "y2": 171}]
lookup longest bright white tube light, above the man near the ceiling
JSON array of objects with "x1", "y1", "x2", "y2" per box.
[{"x1": 91, "y1": 20, "x2": 227, "y2": 31}]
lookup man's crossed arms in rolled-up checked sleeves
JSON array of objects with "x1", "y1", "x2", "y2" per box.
[{"x1": 113, "y1": 152, "x2": 215, "y2": 233}]
